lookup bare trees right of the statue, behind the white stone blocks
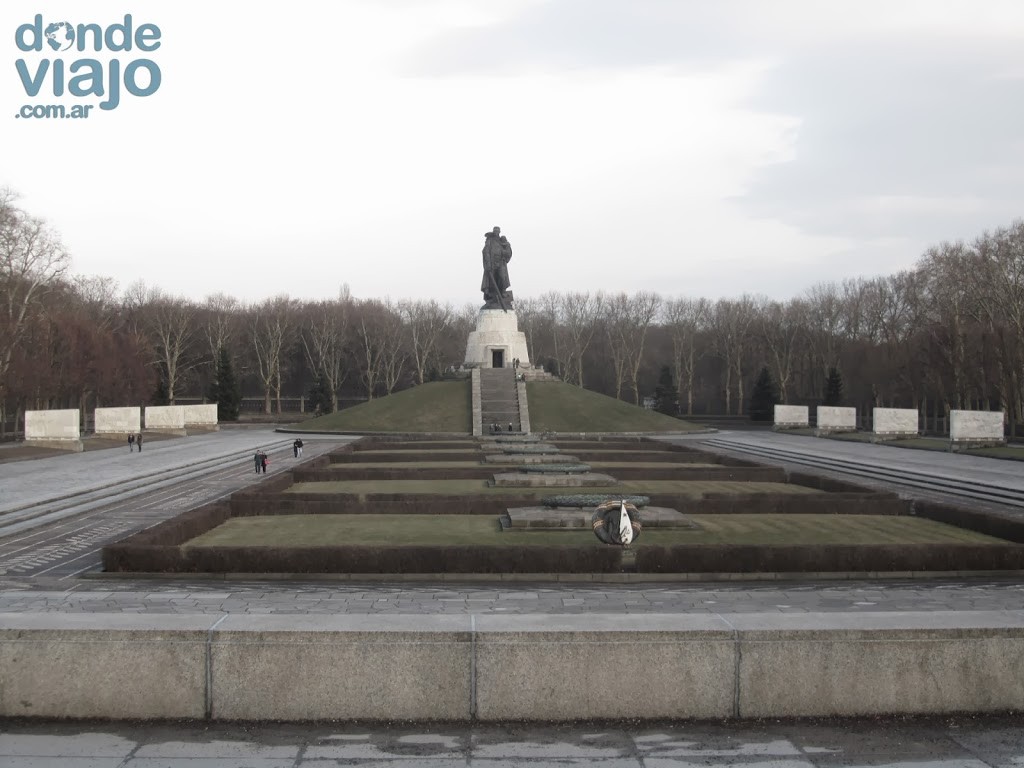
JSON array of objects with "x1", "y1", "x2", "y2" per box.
[{"x1": 518, "y1": 221, "x2": 1024, "y2": 425}]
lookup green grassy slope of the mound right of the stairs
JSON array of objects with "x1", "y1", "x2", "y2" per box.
[{"x1": 526, "y1": 381, "x2": 697, "y2": 432}]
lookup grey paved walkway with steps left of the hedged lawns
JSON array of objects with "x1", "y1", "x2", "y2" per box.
[{"x1": 0, "y1": 427, "x2": 353, "y2": 590}]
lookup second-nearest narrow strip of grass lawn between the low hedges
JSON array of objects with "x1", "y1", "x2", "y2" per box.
[{"x1": 285, "y1": 479, "x2": 822, "y2": 499}]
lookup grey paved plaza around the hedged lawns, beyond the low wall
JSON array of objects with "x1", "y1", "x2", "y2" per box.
[{"x1": 0, "y1": 428, "x2": 1024, "y2": 614}]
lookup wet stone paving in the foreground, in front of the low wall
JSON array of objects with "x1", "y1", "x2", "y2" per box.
[{"x1": 0, "y1": 717, "x2": 1024, "y2": 768}]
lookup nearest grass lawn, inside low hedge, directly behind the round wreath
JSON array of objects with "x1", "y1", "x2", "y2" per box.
[{"x1": 183, "y1": 515, "x2": 1005, "y2": 548}]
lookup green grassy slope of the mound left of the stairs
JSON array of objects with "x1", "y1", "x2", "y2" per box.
[{"x1": 295, "y1": 380, "x2": 473, "y2": 434}]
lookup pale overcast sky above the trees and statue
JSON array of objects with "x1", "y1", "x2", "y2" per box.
[{"x1": 0, "y1": 0, "x2": 1024, "y2": 305}]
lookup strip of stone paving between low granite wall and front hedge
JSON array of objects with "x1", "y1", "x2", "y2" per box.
[{"x1": 6, "y1": 578, "x2": 1024, "y2": 615}]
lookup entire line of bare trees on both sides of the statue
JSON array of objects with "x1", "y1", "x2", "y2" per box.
[{"x1": 0, "y1": 190, "x2": 1024, "y2": 428}]
